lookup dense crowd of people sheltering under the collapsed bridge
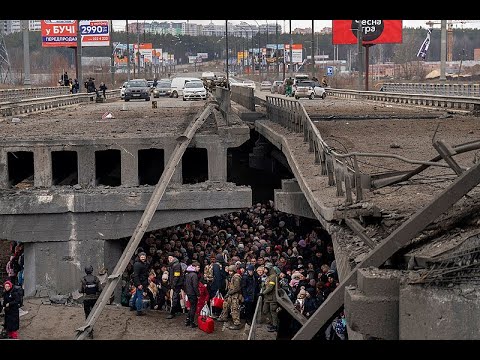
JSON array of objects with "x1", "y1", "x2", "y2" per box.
[{"x1": 122, "y1": 201, "x2": 346, "y2": 340}]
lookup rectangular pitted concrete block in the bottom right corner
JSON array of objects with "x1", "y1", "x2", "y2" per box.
[{"x1": 399, "y1": 285, "x2": 480, "y2": 340}]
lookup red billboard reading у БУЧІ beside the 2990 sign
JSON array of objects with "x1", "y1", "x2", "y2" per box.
[{"x1": 40, "y1": 20, "x2": 77, "y2": 47}]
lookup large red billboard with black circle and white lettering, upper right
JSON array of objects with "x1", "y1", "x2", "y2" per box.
[{"x1": 332, "y1": 20, "x2": 403, "y2": 45}]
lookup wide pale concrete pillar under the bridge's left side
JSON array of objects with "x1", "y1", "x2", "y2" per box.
[{"x1": 24, "y1": 240, "x2": 122, "y2": 297}]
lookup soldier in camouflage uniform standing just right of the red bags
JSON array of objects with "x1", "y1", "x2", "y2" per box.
[{"x1": 218, "y1": 265, "x2": 243, "y2": 330}]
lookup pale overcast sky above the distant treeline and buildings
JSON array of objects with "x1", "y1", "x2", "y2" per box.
[{"x1": 113, "y1": 19, "x2": 438, "y2": 32}]
